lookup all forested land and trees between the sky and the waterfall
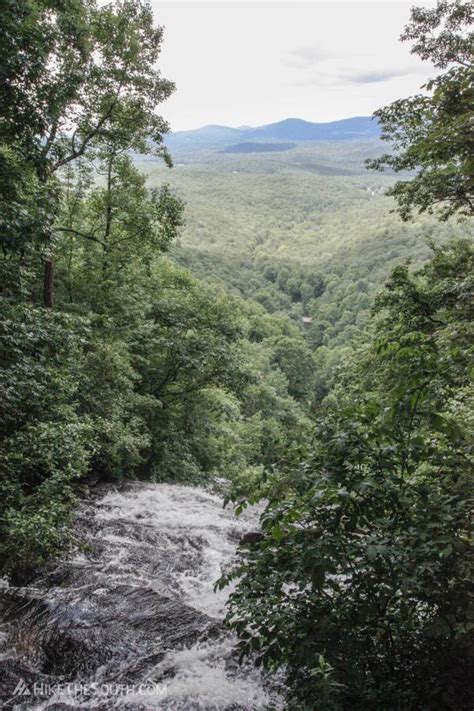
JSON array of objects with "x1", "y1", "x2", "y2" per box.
[{"x1": 0, "y1": 0, "x2": 474, "y2": 711}]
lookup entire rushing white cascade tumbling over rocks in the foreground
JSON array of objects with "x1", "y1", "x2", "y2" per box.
[{"x1": 0, "y1": 482, "x2": 281, "y2": 711}]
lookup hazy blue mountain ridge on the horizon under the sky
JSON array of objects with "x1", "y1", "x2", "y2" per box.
[{"x1": 167, "y1": 116, "x2": 380, "y2": 146}]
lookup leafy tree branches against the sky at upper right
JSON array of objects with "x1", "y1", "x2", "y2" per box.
[{"x1": 368, "y1": 0, "x2": 474, "y2": 219}]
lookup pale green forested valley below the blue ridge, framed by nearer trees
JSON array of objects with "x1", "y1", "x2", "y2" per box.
[{"x1": 137, "y1": 134, "x2": 467, "y2": 347}]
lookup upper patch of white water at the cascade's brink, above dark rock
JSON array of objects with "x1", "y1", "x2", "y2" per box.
[{"x1": 97, "y1": 484, "x2": 252, "y2": 619}]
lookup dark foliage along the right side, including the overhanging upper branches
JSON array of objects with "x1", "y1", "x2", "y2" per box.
[{"x1": 219, "y1": 2, "x2": 474, "y2": 711}]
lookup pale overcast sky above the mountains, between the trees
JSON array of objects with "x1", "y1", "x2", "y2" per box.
[{"x1": 152, "y1": 0, "x2": 433, "y2": 131}]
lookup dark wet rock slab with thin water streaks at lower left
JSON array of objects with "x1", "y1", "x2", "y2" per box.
[{"x1": 4, "y1": 585, "x2": 222, "y2": 678}]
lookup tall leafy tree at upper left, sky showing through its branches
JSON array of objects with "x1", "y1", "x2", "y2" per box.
[{"x1": 0, "y1": 0, "x2": 174, "y2": 306}]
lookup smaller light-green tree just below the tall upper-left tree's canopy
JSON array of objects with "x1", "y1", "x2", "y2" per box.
[{"x1": 54, "y1": 150, "x2": 183, "y2": 310}]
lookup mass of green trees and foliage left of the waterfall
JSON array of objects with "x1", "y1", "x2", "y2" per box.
[{"x1": 0, "y1": 0, "x2": 312, "y2": 581}]
